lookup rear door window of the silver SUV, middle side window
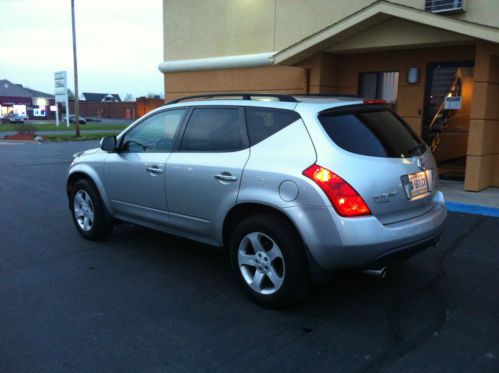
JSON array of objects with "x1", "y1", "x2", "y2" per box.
[{"x1": 180, "y1": 108, "x2": 246, "y2": 151}]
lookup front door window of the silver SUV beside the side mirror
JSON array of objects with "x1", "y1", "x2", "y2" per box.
[{"x1": 121, "y1": 109, "x2": 187, "y2": 153}]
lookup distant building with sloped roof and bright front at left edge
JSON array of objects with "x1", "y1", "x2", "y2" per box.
[{"x1": 0, "y1": 79, "x2": 55, "y2": 120}]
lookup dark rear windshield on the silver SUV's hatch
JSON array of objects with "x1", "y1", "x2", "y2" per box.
[{"x1": 319, "y1": 109, "x2": 426, "y2": 158}]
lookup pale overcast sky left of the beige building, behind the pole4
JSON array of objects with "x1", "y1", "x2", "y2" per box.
[{"x1": 0, "y1": 0, "x2": 163, "y2": 98}]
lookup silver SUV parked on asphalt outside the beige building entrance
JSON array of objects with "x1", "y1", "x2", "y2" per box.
[{"x1": 67, "y1": 94, "x2": 447, "y2": 307}]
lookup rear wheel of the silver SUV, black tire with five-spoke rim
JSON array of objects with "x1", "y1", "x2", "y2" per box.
[{"x1": 229, "y1": 214, "x2": 310, "y2": 308}]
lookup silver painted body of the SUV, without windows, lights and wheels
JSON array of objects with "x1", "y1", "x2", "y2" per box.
[{"x1": 69, "y1": 98, "x2": 446, "y2": 270}]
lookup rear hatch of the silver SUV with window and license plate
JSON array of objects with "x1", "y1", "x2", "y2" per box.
[{"x1": 318, "y1": 104, "x2": 438, "y2": 224}]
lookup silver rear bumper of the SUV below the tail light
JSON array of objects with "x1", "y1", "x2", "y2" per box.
[{"x1": 286, "y1": 192, "x2": 447, "y2": 270}]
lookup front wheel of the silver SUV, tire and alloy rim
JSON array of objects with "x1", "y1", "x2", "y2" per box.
[{"x1": 70, "y1": 179, "x2": 113, "y2": 241}]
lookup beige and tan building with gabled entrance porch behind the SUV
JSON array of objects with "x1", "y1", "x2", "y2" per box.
[{"x1": 159, "y1": 0, "x2": 499, "y2": 191}]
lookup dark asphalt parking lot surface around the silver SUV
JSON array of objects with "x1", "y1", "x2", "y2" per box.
[{"x1": 0, "y1": 142, "x2": 499, "y2": 372}]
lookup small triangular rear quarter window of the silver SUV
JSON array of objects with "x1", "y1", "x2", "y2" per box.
[{"x1": 246, "y1": 108, "x2": 300, "y2": 145}]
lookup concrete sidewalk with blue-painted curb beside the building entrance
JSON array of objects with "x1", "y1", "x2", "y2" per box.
[{"x1": 439, "y1": 180, "x2": 499, "y2": 217}]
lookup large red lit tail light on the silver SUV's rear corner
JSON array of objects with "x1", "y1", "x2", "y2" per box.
[{"x1": 303, "y1": 164, "x2": 371, "y2": 217}]
